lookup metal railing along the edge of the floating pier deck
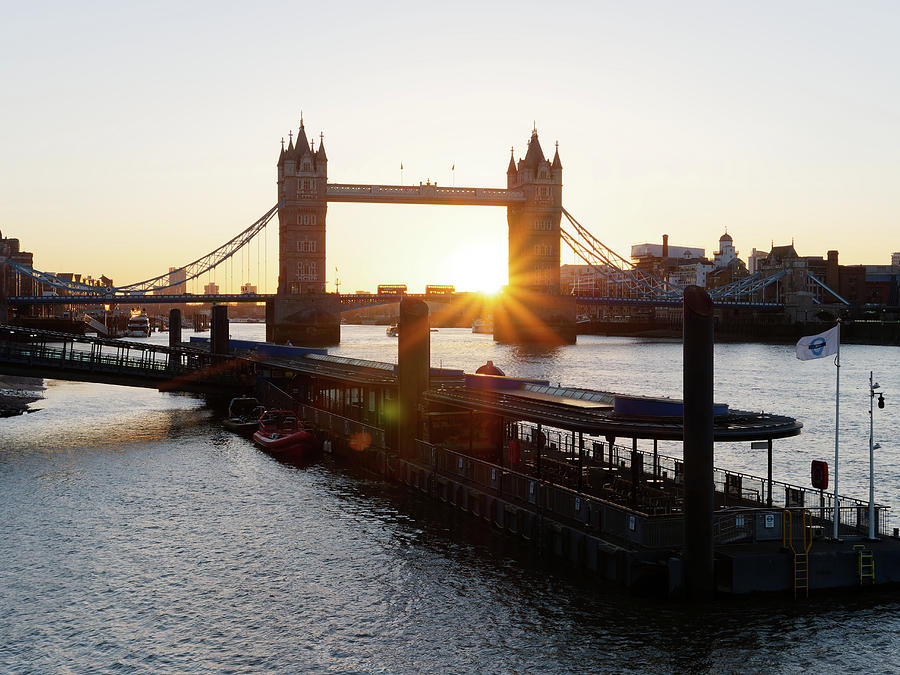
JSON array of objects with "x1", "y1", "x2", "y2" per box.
[{"x1": 250, "y1": 381, "x2": 890, "y2": 549}]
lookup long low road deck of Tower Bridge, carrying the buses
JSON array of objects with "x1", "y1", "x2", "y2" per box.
[{"x1": 8, "y1": 293, "x2": 784, "y2": 311}]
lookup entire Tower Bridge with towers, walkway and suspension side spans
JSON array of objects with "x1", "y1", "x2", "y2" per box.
[{"x1": 0, "y1": 117, "x2": 834, "y2": 345}]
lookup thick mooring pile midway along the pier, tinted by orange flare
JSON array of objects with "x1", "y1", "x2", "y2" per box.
[{"x1": 397, "y1": 298, "x2": 431, "y2": 458}]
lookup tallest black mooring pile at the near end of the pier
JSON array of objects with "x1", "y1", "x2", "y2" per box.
[{"x1": 683, "y1": 286, "x2": 715, "y2": 600}]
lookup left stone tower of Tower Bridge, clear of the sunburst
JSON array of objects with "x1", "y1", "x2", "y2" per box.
[{"x1": 266, "y1": 116, "x2": 341, "y2": 346}]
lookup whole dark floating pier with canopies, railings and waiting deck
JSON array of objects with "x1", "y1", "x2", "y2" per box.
[{"x1": 243, "y1": 299, "x2": 900, "y2": 600}]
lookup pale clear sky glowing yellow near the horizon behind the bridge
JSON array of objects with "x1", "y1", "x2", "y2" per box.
[{"x1": 0, "y1": 0, "x2": 900, "y2": 292}]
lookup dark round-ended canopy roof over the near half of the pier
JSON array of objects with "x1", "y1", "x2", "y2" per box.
[{"x1": 425, "y1": 375, "x2": 803, "y2": 441}]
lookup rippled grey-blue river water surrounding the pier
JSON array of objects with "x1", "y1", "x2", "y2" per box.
[{"x1": 0, "y1": 324, "x2": 900, "y2": 673}]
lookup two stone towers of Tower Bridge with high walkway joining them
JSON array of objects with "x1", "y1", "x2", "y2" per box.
[{"x1": 274, "y1": 117, "x2": 575, "y2": 344}]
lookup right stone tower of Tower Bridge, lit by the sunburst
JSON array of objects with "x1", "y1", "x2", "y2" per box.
[{"x1": 494, "y1": 128, "x2": 575, "y2": 344}]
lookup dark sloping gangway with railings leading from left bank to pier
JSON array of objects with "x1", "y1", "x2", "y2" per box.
[{"x1": 0, "y1": 325, "x2": 256, "y2": 395}]
